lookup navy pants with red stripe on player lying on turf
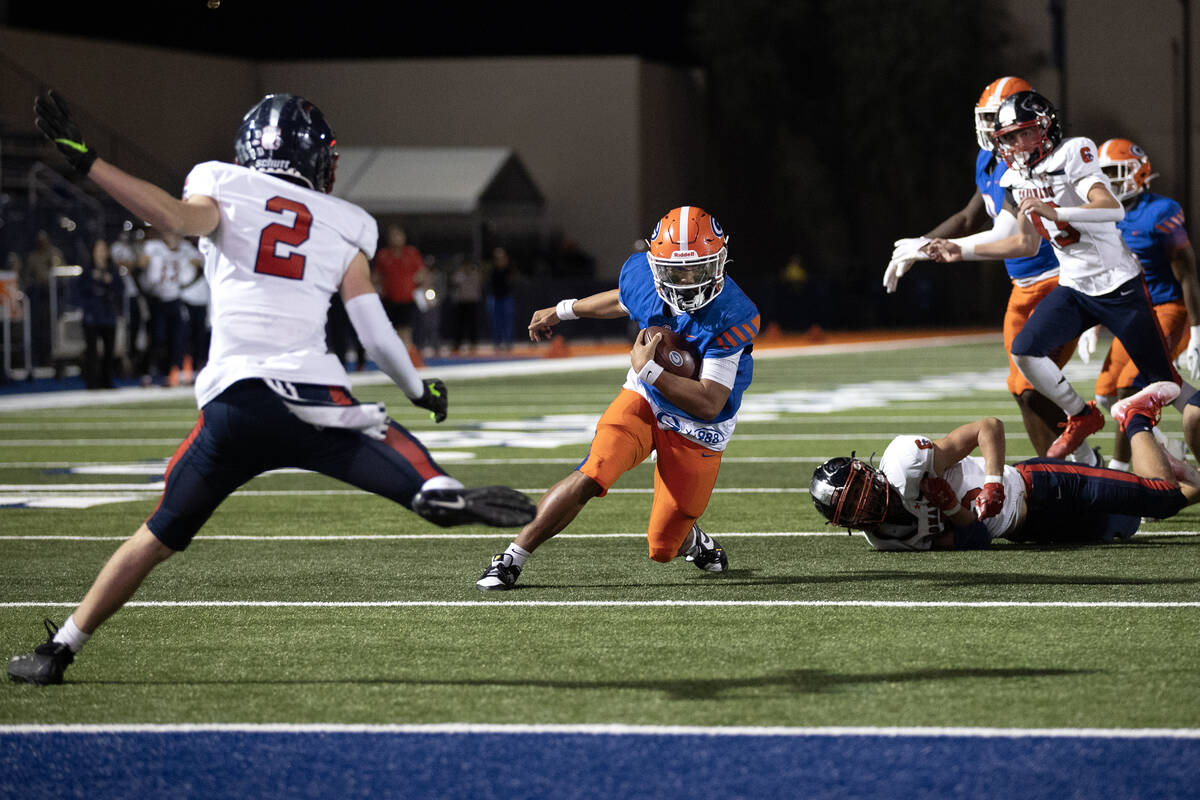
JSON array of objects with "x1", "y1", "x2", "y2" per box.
[{"x1": 1010, "y1": 458, "x2": 1187, "y2": 542}]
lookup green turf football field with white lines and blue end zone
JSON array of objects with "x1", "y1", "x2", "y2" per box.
[{"x1": 0, "y1": 335, "x2": 1200, "y2": 798}]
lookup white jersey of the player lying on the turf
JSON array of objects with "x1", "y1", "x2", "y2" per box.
[{"x1": 866, "y1": 435, "x2": 1025, "y2": 551}]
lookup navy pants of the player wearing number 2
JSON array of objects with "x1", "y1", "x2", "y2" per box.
[{"x1": 146, "y1": 379, "x2": 445, "y2": 551}]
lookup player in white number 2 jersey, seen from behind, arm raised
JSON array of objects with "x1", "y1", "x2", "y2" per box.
[{"x1": 8, "y1": 92, "x2": 535, "y2": 684}]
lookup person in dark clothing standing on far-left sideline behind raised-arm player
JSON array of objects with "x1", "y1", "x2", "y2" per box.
[{"x1": 77, "y1": 239, "x2": 125, "y2": 389}]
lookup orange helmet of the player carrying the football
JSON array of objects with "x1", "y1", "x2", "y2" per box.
[{"x1": 646, "y1": 205, "x2": 730, "y2": 312}]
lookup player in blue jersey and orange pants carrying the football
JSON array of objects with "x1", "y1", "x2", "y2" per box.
[{"x1": 475, "y1": 205, "x2": 760, "y2": 590}]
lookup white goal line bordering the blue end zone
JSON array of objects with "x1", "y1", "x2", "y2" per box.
[{"x1": 0, "y1": 722, "x2": 1200, "y2": 739}]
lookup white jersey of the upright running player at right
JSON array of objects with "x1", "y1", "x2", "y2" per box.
[{"x1": 1000, "y1": 137, "x2": 1141, "y2": 296}]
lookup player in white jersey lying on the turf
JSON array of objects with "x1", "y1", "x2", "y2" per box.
[{"x1": 809, "y1": 381, "x2": 1200, "y2": 551}]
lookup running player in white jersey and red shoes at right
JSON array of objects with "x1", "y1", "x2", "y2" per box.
[{"x1": 928, "y1": 91, "x2": 1200, "y2": 458}]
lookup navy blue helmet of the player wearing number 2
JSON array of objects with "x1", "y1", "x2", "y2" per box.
[{"x1": 234, "y1": 95, "x2": 337, "y2": 192}]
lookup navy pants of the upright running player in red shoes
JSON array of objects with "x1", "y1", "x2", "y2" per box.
[{"x1": 1013, "y1": 277, "x2": 1180, "y2": 383}]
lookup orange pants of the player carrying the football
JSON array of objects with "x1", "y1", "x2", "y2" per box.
[{"x1": 578, "y1": 389, "x2": 721, "y2": 563}]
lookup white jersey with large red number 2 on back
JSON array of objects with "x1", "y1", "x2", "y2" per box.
[{"x1": 184, "y1": 161, "x2": 378, "y2": 407}]
